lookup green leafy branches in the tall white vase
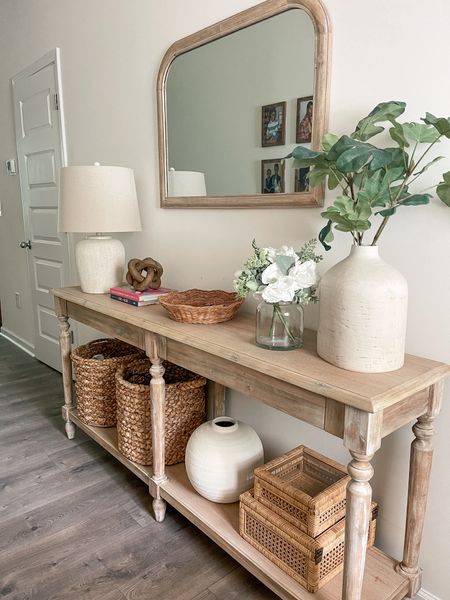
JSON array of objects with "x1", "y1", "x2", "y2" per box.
[{"x1": 286, "y1": 101, "x2": 450, "y2": 250}]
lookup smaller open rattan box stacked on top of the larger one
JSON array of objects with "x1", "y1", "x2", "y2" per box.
[{"x1": 254, "y1": 446, "x2": 350, "y2": 537}]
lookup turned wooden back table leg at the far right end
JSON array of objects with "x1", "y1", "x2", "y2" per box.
[{"x1": 397, "y1": 382, "x2": 443, "y2": 598}]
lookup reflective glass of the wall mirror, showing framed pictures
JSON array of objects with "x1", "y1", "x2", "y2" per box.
[{"x1": 166, "y1": 9, "x2": 315, "y2": 196}]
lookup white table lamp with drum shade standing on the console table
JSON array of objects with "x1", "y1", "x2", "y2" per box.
[{"x1": 58, "y1": 163, "x2": 141, "y2": 294}]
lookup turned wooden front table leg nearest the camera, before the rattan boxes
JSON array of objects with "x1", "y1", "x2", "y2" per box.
[{"x1": 342, "y1": 406, "x2": 382, "y2": 600}]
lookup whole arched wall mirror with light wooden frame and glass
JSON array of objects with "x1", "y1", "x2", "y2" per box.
[{"x1": 157, "y1": 0, "x2": 331, "y2": 208}]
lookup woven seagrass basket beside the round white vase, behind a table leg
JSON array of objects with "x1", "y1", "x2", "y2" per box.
[{"x1": 116, "y1": 359, "x2": 206, "y2": 465}]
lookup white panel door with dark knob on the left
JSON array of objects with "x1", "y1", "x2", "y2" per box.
[{"x1": 12, "y1": 50, "x2": 74, "y2": 370}]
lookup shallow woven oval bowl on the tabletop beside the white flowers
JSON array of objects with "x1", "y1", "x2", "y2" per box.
[{"x1": 159, "y1": 289, "x2": 244, "y2": 324}]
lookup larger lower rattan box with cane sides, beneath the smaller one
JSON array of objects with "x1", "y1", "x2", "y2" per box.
[{"x1": 239, "y1": 491, "x2": 377, "y2": 592}]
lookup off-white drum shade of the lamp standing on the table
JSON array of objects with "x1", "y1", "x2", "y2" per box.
[{"x1": 58, "y1": 165, "x2": 141, "y2": 233}]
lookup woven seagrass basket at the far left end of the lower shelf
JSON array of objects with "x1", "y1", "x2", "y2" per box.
[{"x1": 71, "y1": 339, "x2": 143, "y2": 427}]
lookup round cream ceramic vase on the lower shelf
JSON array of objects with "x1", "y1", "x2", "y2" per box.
[{"x1": 185, "y1": 417, "x2": 264, "y2": 503}]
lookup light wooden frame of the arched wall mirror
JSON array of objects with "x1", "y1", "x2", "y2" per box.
[{"x1": 156, "y1": 0, "x2": 331, "y2": 208}]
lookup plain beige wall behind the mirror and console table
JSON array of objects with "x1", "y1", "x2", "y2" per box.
[{"x1": 0, "y1": 0, "x2": 450, "y2": 600}]
